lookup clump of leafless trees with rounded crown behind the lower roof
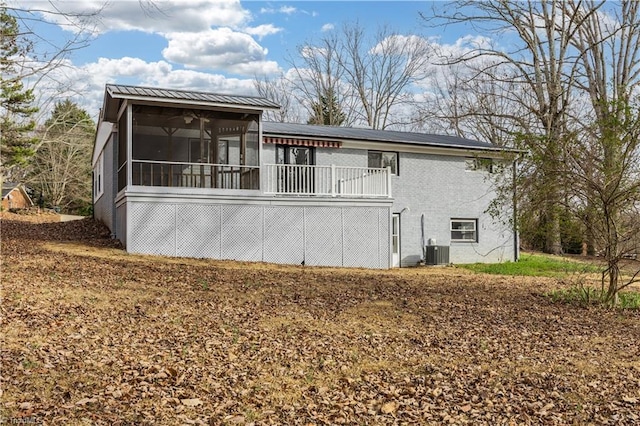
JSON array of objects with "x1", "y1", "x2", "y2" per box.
[{"x1": 290, "y1": 23, "x2": 432, "y2": 129}]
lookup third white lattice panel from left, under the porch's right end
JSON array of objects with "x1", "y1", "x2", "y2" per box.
[{"x1": 220, "y1": 205, "x2": 263, "y2": 261}]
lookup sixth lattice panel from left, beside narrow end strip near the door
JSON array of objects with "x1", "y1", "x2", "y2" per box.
[{"x1": 342, "y1": 207, "x2": 379, "y2": 268}]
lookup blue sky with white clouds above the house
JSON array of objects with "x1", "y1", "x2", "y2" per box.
[{"x1": 8, "y1": 0, "x2": 478, "y2": 120}]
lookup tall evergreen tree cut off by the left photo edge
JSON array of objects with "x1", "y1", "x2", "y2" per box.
[{"x1": 0, "y1": 4, "x2": 38, "y2": 183}]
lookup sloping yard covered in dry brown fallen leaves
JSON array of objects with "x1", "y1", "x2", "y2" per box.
[{"x1": 0, "y1": 214, "x2": 640, "y2": 425}]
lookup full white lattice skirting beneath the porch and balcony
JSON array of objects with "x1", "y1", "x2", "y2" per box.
[{"x1": 125, "y1": 201, "x2": 390, "y2": 268}]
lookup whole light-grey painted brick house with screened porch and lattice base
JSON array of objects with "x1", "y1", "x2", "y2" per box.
[{"x1": 93, "y1": 84, "x2": 517, "y2": 268}]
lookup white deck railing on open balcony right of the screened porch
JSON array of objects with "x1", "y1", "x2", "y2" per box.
[{"x1": 262, "y1": 164, "x2": 391, "y2": 197}]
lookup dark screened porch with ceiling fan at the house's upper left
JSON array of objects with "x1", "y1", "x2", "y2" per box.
[{"x1": 118, "y1": 103, "x2": 260, "y2": 190}]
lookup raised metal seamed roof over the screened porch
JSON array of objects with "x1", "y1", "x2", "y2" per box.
[{"x1": 106, "y1": 84, "x2": 280, "y2": 109}]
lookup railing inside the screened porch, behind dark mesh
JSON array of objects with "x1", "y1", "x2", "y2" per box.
[{"x1": 131, "y1": 160, "x2": 260, "y2": 189}]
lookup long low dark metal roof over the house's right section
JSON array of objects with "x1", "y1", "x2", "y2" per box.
[{"x1": 262, "y1": 121, "x2": 511, "y2": 151}]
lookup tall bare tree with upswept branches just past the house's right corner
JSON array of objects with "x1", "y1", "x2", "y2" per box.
[{"x1": 423, "y1": 0, "x2": 600, "y2": 254}]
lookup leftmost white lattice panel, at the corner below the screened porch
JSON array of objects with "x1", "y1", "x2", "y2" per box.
[{"x1": 127, "y1": 202, "x2": 176, "y2": 256}]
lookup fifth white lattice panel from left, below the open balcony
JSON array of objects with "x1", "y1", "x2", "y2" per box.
[{"x1": 305, "y1": 207, "x2": 342, "y2": 266}]
